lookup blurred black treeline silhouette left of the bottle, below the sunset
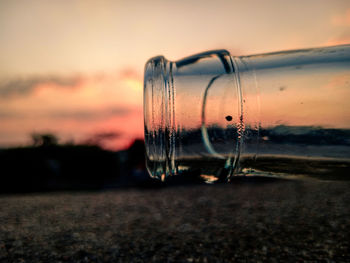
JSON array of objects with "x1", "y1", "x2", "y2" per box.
[{"x1": 0, "y1": 134, "x2": 152, "y2": 193}]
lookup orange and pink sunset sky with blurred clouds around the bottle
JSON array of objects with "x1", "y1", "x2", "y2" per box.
[{"x1": 0, "y1": 0, "x2": 350, "y2": 149}]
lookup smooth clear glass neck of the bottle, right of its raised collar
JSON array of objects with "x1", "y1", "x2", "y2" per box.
[{"x1": 232, "y1": 45, "x2": 350, "y2": 172}]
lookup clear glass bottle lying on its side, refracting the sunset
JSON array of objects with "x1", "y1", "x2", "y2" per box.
[{"x1": 144, "y1": 45, "x2": 350, "y2": 182}]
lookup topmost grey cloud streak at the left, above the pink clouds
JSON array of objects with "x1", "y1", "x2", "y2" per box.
[{"x1": 0, "y1": 75, "x2": 80, "y2": 98}]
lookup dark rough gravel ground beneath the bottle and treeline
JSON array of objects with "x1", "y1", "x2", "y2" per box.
[{"x1": 0, "y1": 179, "x2": 350, "y2": 262}]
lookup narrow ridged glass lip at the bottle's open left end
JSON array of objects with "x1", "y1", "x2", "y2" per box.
[{"x1": 144, "y1": 56, "x2": 175, "y2": 180}]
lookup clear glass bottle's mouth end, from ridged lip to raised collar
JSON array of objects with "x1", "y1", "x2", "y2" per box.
[{"x1": 144, "y1": 50, "x2": 243, "y2": 183}]
